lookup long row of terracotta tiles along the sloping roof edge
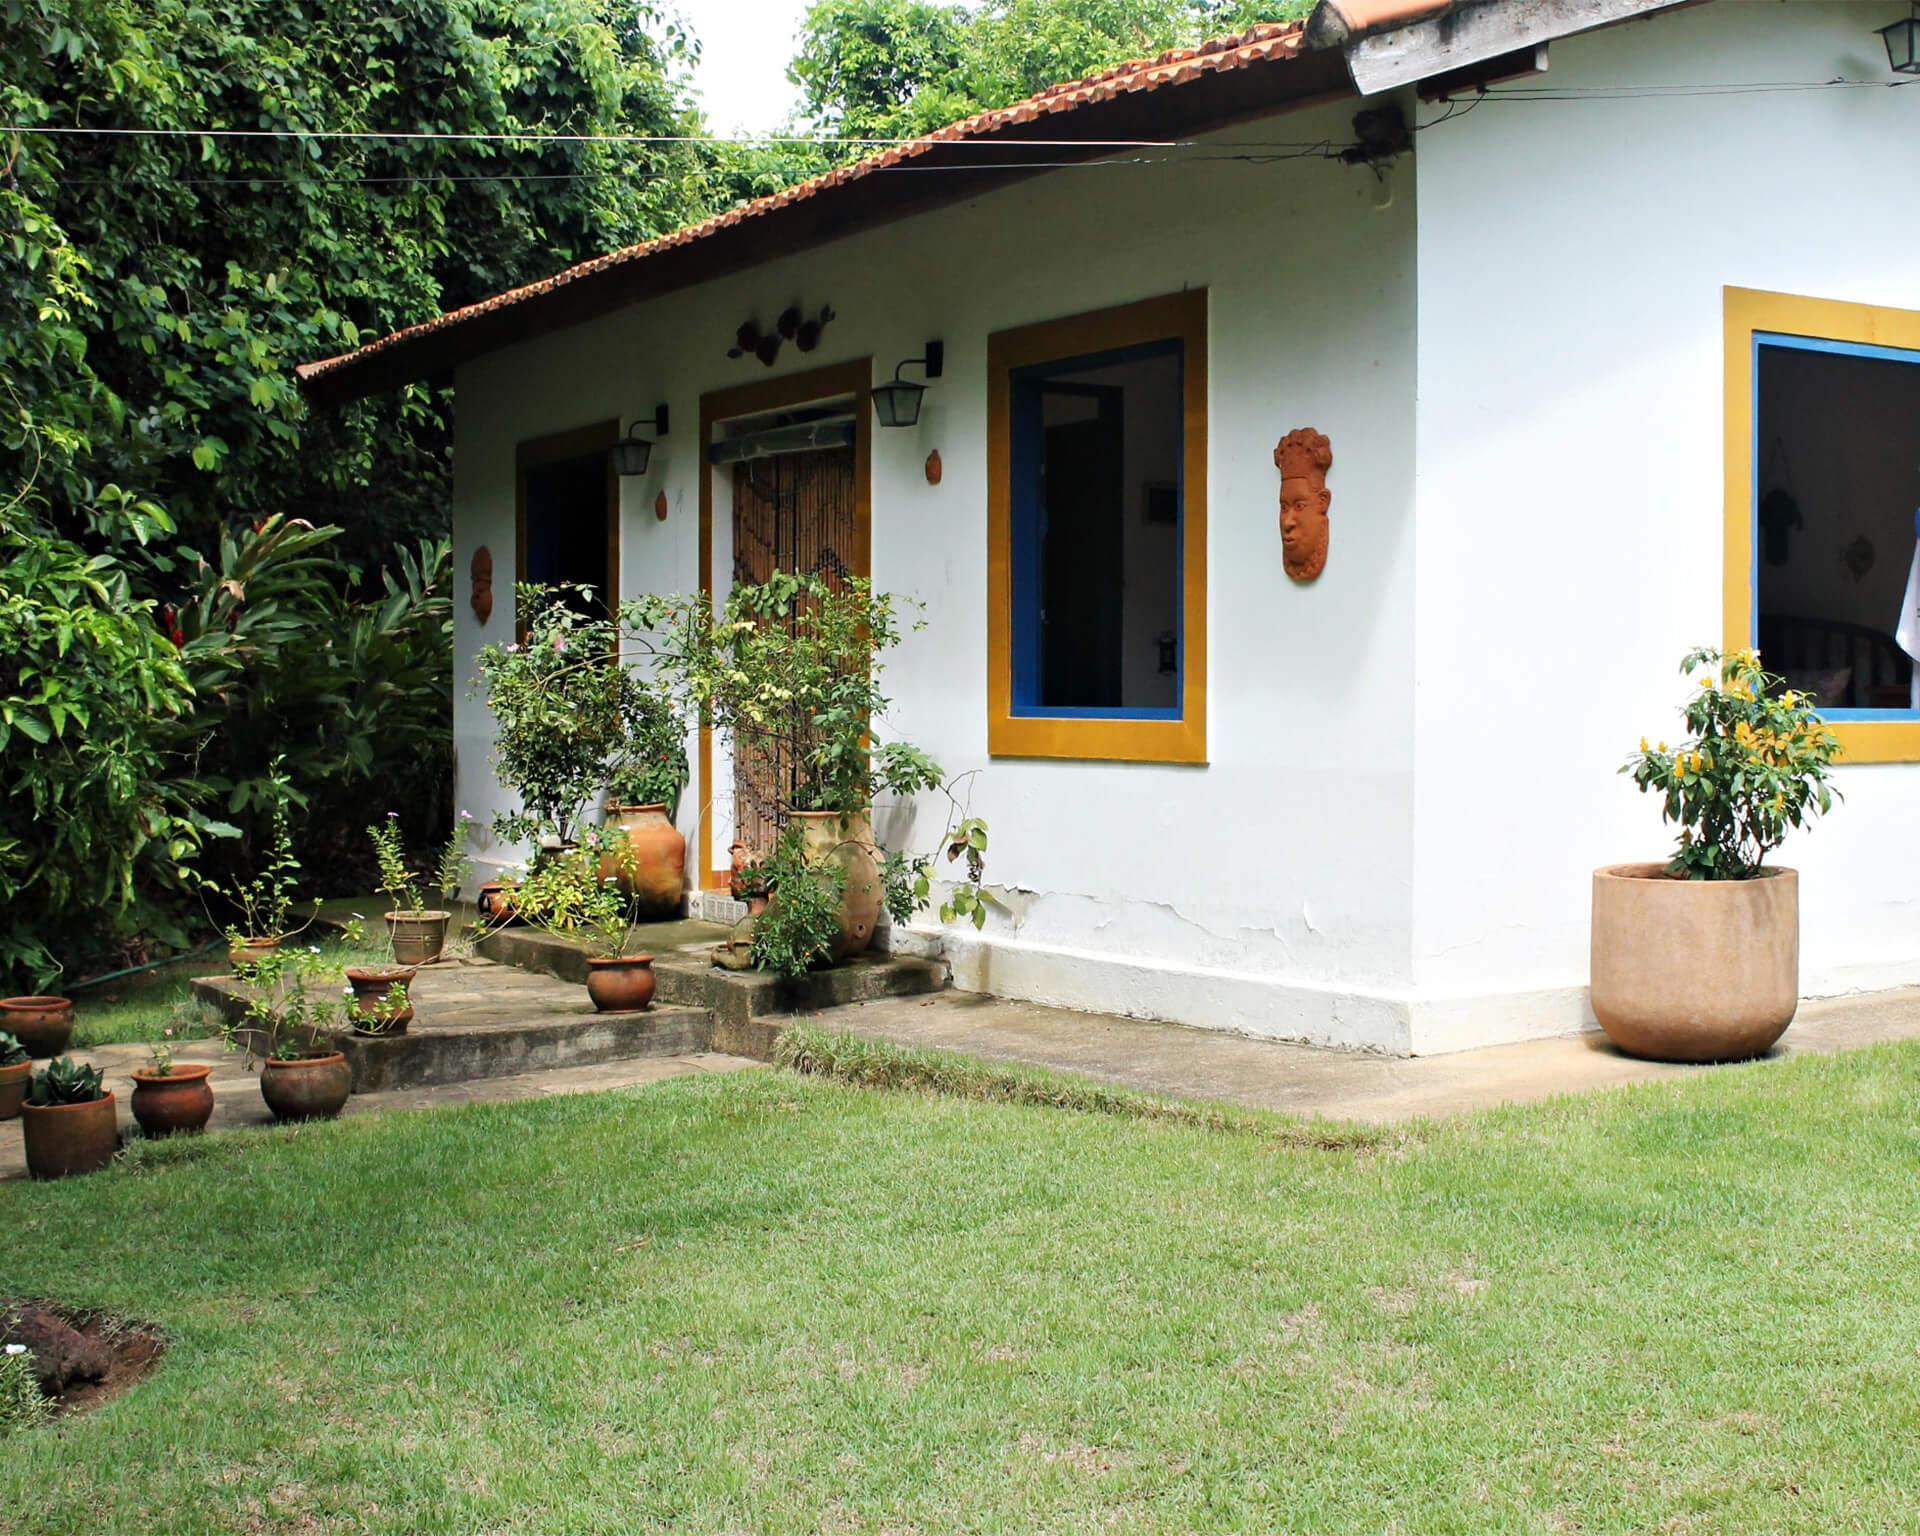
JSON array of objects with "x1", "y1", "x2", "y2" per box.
[{"x1": 296, "y1": 21, "x2": 1313, "y2": 386}]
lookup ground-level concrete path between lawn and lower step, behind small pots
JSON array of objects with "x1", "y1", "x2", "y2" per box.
[{"x1": 0, "y1": 1041, "x2": 760, "y2": 1179}]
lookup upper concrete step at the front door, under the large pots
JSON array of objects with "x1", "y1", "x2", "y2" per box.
[{"x1": 478, "y1": 922, "x2": 947, "y2": 1062}]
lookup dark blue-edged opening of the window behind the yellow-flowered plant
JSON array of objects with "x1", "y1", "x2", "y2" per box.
[{"x1": 1753, "y1": 336, "x2": 1920, "y2": 712}]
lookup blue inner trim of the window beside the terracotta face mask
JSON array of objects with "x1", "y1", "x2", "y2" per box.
[{"x1": 1008, "y1": 336, "x2": 1187, "y2": 720}]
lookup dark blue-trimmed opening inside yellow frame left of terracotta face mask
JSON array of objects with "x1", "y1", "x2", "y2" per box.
[{"x1": 1010, "y1": 340, "x2": 1185, "y2": 718}]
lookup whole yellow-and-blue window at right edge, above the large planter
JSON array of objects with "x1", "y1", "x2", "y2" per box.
[{"x1": 1726, "y1": 290, "x2": 1920, "y2": 760}]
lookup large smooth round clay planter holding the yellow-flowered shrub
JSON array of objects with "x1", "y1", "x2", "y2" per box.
[{"x1": 1592, "y1": 864, "x2": 1799, "y2": 1062}]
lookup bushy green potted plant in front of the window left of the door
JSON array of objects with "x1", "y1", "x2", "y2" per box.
[{"x1": 478, "y1": 586, "x2": 643, "y2": 843}]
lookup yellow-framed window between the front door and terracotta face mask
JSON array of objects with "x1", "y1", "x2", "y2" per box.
[{"x1": 989, "y1": 294, "x2": 1206, "y2": 762}]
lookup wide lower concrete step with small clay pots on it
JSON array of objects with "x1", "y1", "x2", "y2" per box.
[{"x1": 194, "y1": 960, "x2": 714, "y2": 1092}]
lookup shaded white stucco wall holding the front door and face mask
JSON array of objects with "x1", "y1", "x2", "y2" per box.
[{"x1": 455, "y1": 93, "x2": 1415, "y2": 1050}]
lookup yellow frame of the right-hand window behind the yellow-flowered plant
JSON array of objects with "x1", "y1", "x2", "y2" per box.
[{"x1": 1722, "y1": 288, "x2": 1920, "y2": 762}]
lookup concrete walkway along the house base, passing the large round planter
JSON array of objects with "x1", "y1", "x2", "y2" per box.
[{"x1": 814, "y1": 987, "x2": 1920, "y2": 1121}]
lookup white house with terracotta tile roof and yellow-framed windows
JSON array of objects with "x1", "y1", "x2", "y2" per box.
[{"x1": 301, "y1": 0, "x2": 1920, "y2": 1052}]
